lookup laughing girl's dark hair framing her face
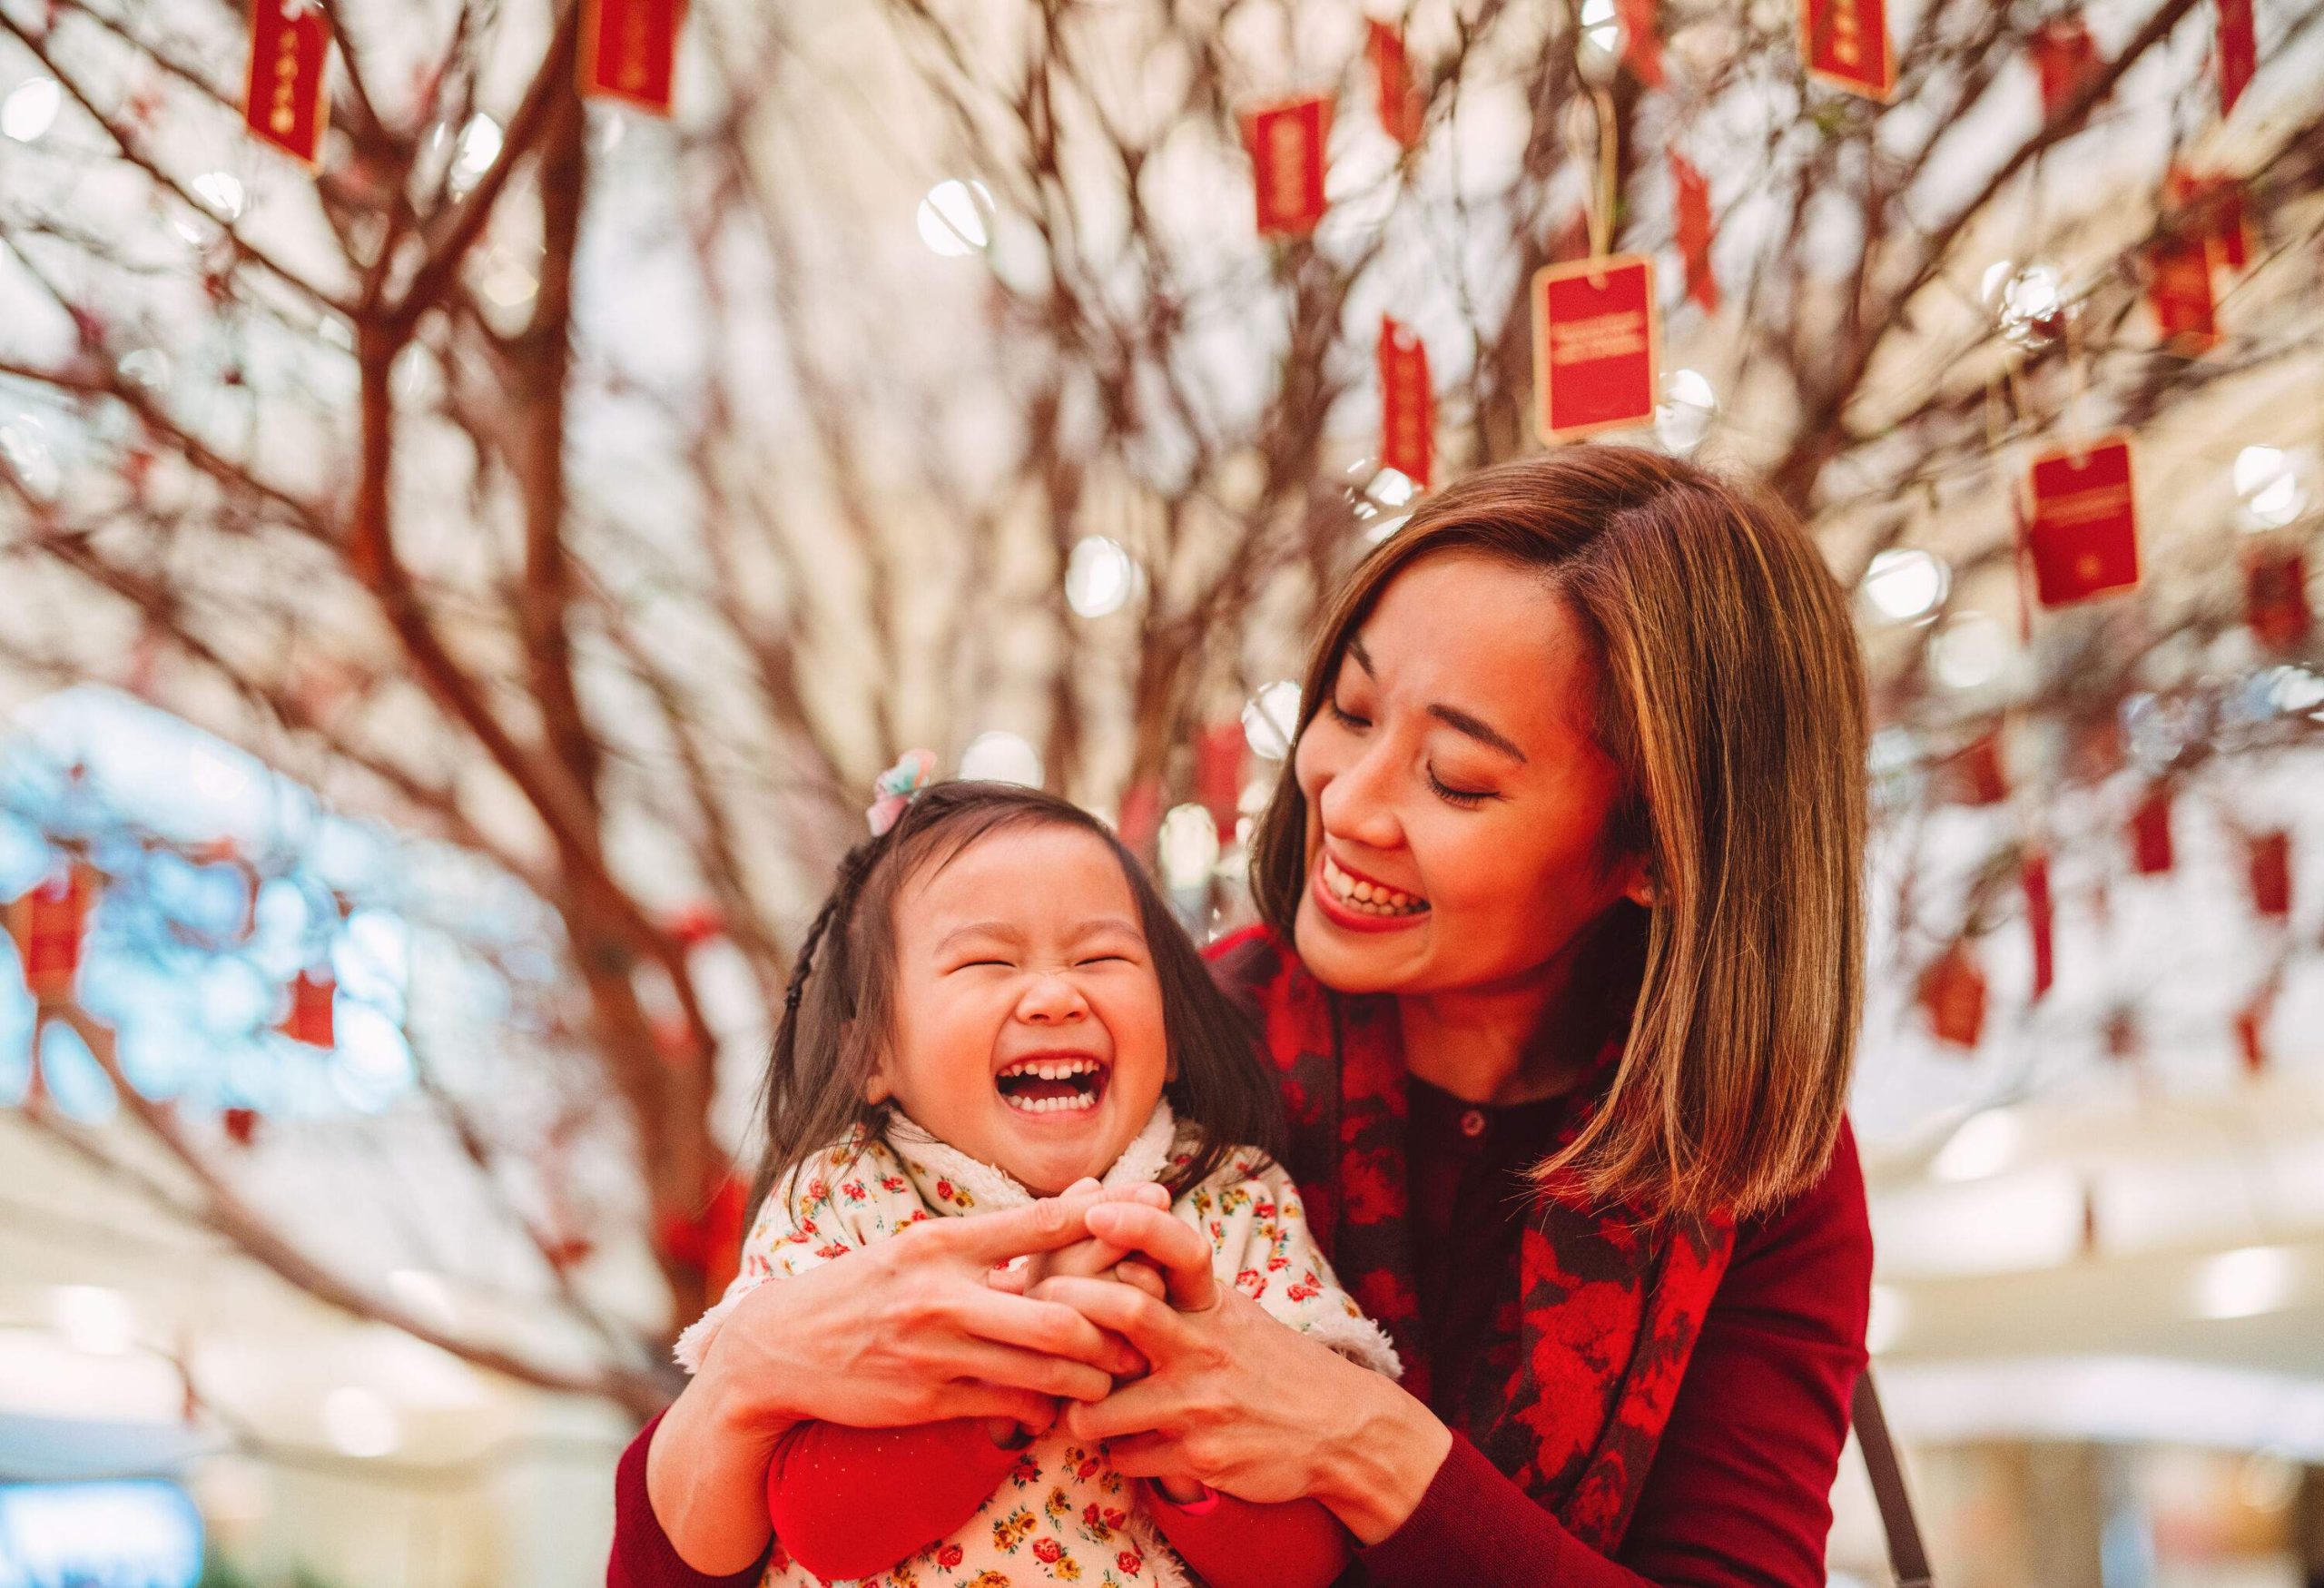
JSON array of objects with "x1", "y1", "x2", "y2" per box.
[{"x1": 751, "y1": 784, "x2": 1283, "y2": 1207}]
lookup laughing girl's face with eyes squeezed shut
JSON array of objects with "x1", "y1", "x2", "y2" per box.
[{"x1": 869, "y1": 825, "x2": 1169, "y2": 1195}]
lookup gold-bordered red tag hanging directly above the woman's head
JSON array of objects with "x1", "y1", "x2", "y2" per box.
[{"x1": 1534, "y1": 253, "x2": 1661, "y2": 447}]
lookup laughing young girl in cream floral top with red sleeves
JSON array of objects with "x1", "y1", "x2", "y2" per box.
[{"x1": 679, "y1": 751, "x2": 1399, "y2": 1588}]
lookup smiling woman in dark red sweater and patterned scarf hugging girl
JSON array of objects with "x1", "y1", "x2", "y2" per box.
[{"x1": 611, "y1": 447, "x2": 1871, "y2": 1588}]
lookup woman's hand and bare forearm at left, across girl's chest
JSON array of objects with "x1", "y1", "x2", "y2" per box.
[{"x1": 646, "y1": 1186, "x2": 1150, "y2": 1574}]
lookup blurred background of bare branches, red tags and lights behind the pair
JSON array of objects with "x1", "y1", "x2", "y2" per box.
[{"x1": 0, "y1": 0, "x2": 2324, "y2": 1588}]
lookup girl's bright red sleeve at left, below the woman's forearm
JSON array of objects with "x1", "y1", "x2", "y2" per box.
[{"x1": 767, "y1": 1418, "x2": 1018, "y2": 1579}]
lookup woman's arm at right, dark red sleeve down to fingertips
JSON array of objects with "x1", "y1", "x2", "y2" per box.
[{"x1": 1041, "y1": 1135, "x2": 1871, "y2": 1588}]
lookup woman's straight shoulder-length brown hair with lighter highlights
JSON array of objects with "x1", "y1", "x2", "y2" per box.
[{"x1": 1250, "y1": 447, "x2": 1866, "y2": 1216}]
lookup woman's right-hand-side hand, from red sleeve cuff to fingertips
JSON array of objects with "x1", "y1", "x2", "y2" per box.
[{"x1": 1032, "y1": 1202, "x2": 1452, "y2": 1544}]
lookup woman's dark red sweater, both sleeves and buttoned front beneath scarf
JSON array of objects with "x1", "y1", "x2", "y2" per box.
[{"x1": 606, "y1": 1083, "x2": 1871, "y2": 1588}]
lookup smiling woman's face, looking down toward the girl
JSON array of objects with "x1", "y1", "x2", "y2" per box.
[{"x1": 1295, "y1": 551, "x2": 1648, "y2": 992}]
